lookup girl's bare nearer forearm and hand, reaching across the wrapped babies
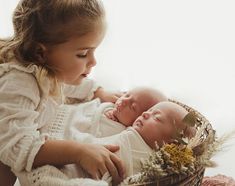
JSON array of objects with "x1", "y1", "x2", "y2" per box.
[{"x1": 33, "y1": 140, "x2": 124, "y2": 183}]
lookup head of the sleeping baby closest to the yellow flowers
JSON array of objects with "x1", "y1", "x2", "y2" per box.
[{"x1": 133, "y1": 101, "x2": 196, "y2": 149}]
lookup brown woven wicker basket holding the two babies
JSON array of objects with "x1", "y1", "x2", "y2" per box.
[{"x1": 126, "y1": 99, "x2": 215, "y2": 186}]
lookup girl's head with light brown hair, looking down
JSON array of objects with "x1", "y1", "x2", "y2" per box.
[{"x1": 1, "y1": 0, "x2": 105, "y2": 84}]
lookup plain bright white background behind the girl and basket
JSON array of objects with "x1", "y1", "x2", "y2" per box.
[{"x1": 0, "y1": 0, "x2": 235, "y2": 178}]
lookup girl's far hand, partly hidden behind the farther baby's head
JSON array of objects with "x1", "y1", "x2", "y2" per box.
[{"x1": 94, "y1": 87, "x2": 123, "y2": 103}]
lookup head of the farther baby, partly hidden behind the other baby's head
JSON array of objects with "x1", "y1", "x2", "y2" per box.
[{"x1": 113, "y1": 87, "x2": 167, "y2": 126}]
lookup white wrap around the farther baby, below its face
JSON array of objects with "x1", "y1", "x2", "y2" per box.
[{"x1": 64, "y1": 99, "x2": 126, "y2": 140}]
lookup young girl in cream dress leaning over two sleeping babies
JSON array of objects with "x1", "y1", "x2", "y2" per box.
[{"x1": 0, "y1": 0, "x2": 124, "y2": 184}]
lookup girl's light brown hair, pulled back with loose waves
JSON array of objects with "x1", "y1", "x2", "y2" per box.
[{"x1": 0, "y1": 0, "x2": 104, "y2": 97}]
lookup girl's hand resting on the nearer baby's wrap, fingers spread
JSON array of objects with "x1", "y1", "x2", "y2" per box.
[{"x1": 77, "y1": 144, "x2": 124, "y2": 183}]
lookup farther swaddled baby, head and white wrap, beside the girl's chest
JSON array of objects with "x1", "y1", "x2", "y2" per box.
[{"x1": 65, "y1": 87, "x2": 167, "y2": 139}]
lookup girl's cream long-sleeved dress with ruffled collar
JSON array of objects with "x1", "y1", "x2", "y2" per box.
[{"x1": 0, "y1": 63, "x2": 104, "y2": 185}]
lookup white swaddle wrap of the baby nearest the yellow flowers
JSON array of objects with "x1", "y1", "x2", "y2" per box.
[{"x1": 63, "y1": 127, "x2": 153, "y2": 178}]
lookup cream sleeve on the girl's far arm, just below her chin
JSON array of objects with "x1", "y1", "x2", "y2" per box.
[{"x1": 64, "y1": 78, "x2": 99, "y2": 101}]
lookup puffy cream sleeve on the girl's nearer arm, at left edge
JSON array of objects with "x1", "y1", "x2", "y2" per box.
[{"x1": 0, "y1": 69, "x2": 46, "y2": 171}]
